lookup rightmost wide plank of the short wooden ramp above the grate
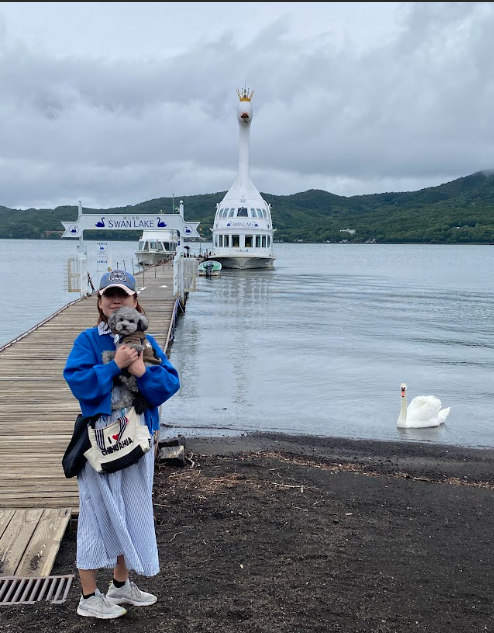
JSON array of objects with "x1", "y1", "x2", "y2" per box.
[{"x1": 15, "y1": 508, "x2": 71, "y2": 576}]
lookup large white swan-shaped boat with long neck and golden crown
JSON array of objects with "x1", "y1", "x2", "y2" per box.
[{"x1": 208, "y1": 88, "x2": 276, "y2": 269}]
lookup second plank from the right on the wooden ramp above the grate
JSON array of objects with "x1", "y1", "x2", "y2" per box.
[{"x1": 0, "y1": 509, "x2": 43, "y2": 576}]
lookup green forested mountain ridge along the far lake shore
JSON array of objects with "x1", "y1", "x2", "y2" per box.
[{"x1": 0, "y1": 171, "x2": 494, "y2": 244}]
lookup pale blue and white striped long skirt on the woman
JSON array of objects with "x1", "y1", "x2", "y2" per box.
[{"x1": 77, "y1": 409, "x2": 159, "y2": 576}]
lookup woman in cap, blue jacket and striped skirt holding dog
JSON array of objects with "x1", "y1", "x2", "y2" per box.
[{"x1": 64, "y1": 270, "x2": 180, "y2": 619}]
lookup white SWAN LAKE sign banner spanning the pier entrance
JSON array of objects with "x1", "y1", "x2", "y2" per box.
[{"x1": 62, "y1": 213, "x2": 200, "y2": 239}]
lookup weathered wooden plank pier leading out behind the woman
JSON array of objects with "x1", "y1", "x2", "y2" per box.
[{"x1": 0, "y1": 263, "x2": 178, "y2": 576}]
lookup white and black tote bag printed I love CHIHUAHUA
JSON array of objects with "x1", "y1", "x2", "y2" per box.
[{"x1": 84, "y1": 407, "x2": 152, "y2": 473}]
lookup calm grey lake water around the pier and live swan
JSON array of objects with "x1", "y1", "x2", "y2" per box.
[{"x1": 0, "y1": 240, "x2": 494, "y2": 447}]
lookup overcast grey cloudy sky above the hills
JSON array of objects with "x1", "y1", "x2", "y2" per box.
[{"x1": 0, "y1": 2, "x2": 494, "y2": 212}]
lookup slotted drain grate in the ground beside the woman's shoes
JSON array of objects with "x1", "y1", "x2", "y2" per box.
[{"x1": 0, "y1": 574, "x2": 74, "y2": 607}]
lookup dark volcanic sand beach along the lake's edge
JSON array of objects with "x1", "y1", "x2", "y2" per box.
[{"x1": 0, "y1": 434, "x2": 494, "y2": 633}]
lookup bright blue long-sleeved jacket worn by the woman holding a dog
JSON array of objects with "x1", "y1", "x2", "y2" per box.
[{"x1": 63, "y1": 327, "x2": 180, "y2": 432}]
